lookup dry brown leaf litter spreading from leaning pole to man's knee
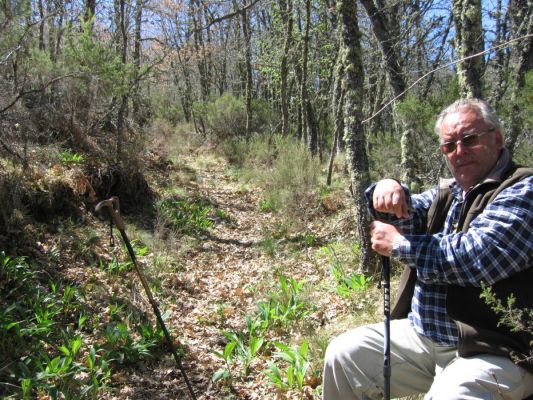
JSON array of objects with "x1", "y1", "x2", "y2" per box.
[{"x1": 88, "y1": 149, "x2": 379, "y2": 399}]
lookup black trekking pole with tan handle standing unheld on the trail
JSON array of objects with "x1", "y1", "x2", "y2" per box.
[{"x1": 95, "y1": 196, "x2": 196, "y2": 400}]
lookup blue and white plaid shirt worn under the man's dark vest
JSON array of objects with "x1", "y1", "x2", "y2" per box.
[{"x1": 366, "y1": 176, "x2": 533, "y2": 345}]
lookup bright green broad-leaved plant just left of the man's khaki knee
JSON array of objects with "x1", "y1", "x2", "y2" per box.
[{"x1": 265, "y1": 340, "x2": 311, "y2": 390}]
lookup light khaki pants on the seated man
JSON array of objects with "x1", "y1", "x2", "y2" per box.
[{"x1": 323, "y1": 319, "x2": 533, "y2": 400}]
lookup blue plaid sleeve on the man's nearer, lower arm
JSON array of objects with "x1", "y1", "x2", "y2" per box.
[{"x1": 394, "y1": 177, "x2": 533, "y2": 286}]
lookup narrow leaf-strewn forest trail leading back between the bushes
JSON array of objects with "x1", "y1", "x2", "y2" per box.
[{"x1": 110, "y1": 156, "x2": 323, "y2": 400}]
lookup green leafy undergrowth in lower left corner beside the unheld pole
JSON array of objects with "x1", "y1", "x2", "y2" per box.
[{"x1": 0, "y1": 246, "x2": 170, "y2": 399}]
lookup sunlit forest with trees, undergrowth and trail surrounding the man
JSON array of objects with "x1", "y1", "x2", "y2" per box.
[{"x1": 0, "y1": 0, "x2": 533, "y2": 400}]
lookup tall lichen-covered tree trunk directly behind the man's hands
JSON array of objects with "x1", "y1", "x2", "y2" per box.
[{"x1": 337, "y1": 0, "x2": 376, "y2": 273}]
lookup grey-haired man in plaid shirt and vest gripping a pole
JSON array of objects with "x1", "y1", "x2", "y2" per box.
[{"x1": 323, "y1": 99, "x2": 533, "y2": 400}]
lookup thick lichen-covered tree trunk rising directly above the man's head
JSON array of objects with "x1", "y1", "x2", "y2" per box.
[{"x1": 452, "y1": 0, "x2": 483, "y2": 98}]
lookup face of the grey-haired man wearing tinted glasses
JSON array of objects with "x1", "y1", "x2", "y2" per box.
[{"x1": 439, "y1": 108, "x2": 503, "y2": 191}]
